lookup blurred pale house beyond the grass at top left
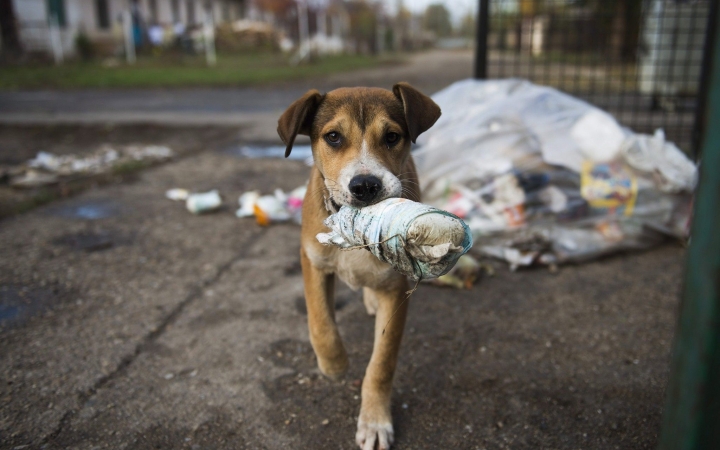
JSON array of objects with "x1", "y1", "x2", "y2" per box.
[{"x1": 13, "y1": 0, "x2": 248, "y2": 56}]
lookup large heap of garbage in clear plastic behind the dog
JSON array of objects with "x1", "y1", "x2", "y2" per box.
[{"x1": 413, "y1": 79, "x2": 697, "y2": 269}]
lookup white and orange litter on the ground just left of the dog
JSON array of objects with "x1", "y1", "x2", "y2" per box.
[{"x1": 235, "y1": 186, "x2": 307, "y2": 226}]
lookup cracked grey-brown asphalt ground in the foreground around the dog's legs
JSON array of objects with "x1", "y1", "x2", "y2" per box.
[{"x1": 0, "y1": 141, "x2": 683, "y2": 449}]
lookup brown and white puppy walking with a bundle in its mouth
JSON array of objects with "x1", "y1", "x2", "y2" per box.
[{"x1": 278, "y1": 83, "x2": 440, "y2": 450}]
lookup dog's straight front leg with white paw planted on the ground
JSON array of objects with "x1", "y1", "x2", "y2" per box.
[{"x1": 355, "y1": 277, "x2": 408, "y2": 450}]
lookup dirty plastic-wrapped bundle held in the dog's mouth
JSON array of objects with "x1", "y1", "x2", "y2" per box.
[{"x1": 317, "y1": 198, "x2": 473, "y2": 280}]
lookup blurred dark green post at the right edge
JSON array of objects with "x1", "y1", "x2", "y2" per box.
[{"x1": 659, "y1": 1, "x2": 720, "y2": 450}]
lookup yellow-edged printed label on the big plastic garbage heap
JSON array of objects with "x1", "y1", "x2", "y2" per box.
[{"x1": 580, "y1": 161, "x2": 637, "y2": 216}]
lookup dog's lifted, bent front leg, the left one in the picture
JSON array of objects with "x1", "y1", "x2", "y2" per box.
[{"x1": 300, "y1": 249, "x2": 348, "y2": 381}]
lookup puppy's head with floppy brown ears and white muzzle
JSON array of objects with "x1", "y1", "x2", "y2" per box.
[{"x1": 278, "y1": 83, "x2": 440, "y2": 210}]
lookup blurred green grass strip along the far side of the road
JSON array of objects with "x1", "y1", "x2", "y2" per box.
[{"x1": 0, "y1": 53, "x2": 389, "y2": 90}]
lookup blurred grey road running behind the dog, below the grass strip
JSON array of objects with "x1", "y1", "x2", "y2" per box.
[{"x1": 0, "y1": 50, "x2": 473, "y2": 142}]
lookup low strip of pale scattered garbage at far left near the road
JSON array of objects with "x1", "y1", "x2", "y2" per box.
[{"x1": 10, "y1": 145, "x2": 173, "y2": 188}]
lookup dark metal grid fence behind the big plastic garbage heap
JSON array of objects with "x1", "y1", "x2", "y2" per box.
[{"x1": 478, "y1": 0, "x2": 717, "y2": 153}]
